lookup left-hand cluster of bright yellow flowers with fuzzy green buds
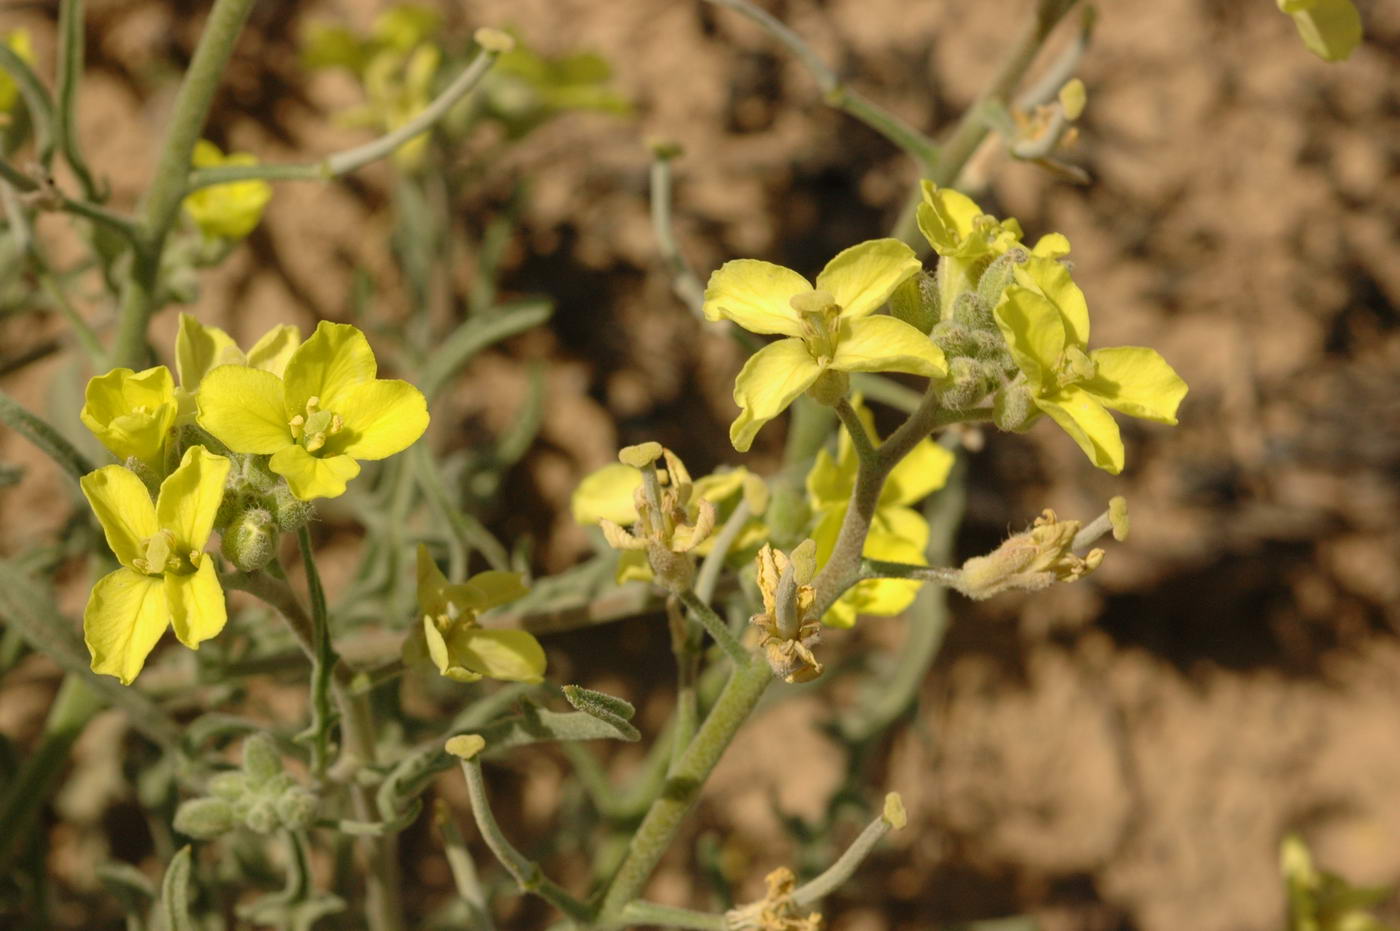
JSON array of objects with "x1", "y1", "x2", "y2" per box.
[{"x1": 80, "y1": 316, "x2": 428, "y2": 683}]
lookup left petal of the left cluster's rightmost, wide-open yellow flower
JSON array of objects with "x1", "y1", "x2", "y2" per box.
[{"x1": 199, "y1": 365, "x2": 293, "y2": 455}]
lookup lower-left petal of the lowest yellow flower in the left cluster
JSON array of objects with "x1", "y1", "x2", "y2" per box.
[{"x1": 83, "y1": 568, "x2": 169, "y2": 685}]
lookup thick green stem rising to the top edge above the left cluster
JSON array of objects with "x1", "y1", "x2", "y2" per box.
[{"x1": 112, "y1": 0, "x2": 255, "y2": 368}]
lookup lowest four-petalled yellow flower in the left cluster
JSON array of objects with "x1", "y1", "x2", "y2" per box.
[{"x1": 80, "y1": 447, "x2": 228, "y2": 685}]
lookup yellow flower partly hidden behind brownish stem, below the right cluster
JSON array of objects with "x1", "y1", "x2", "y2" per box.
[{"x1": 806, "y1": 398, "x2": 953, "y2": 627}]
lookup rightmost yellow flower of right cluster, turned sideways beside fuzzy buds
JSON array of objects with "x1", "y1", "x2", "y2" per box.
[{"x1": 995, "y1": 256, "x2": 1186, "y2": 475}]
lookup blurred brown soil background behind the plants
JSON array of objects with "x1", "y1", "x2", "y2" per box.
[{"x1": 0, "y1": 0, "x2": 1400, "y2": 931}]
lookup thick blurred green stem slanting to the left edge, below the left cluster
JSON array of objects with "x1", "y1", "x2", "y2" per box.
[{"x1": 0, "y1": 673, "x2": 102, "y2": 875}]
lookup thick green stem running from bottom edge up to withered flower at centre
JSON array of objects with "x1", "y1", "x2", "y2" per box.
[{"x1": 599, "y1": 657, "x2": 773, "y2": 927}]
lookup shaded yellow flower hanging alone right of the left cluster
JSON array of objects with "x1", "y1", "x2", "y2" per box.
[{"x1": 409, "y1": 543, "x2": 545, "y2": 682}]
